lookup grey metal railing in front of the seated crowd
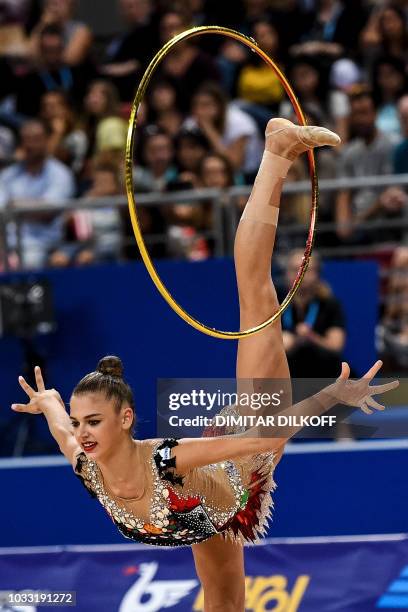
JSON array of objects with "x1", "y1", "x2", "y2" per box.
[{"x1": 0, "y1": 174, "x2": 408, "y2": 270}]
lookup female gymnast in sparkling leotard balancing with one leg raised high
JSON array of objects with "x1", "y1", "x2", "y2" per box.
[{"x1": 12, "y1": 119, "x2": 398, "y2": 612}]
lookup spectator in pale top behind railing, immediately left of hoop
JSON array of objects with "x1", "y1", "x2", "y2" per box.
[{"x1": 49, "y1": 161, "x2": 123, "y2": 267}]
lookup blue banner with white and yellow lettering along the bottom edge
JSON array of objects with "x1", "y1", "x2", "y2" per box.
[{"x1": 0, "y1": 536, "x2": 408, "y2": 612}]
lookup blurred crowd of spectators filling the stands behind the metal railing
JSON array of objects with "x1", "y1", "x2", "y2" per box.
[{"x1": 0, "y1": 0, "x2": 408, "y2": 368}]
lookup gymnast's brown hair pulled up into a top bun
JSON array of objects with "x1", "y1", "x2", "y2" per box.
[{"x1": 72, "y1": 355, "x2": 135, "y2": 428}]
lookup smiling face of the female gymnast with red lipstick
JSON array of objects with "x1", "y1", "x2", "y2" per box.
[{"x1": 70, "y1": 393, "x2": 133, "y2": 460}]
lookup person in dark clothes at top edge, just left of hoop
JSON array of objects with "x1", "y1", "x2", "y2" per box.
[{"x1": 100, "y1": 0, "x2": 158, "y2": 102}]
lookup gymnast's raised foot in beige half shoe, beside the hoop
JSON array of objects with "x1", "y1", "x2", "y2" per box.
[{"x1": 265, "y1": 119, "x2": 341, "y2": 161}]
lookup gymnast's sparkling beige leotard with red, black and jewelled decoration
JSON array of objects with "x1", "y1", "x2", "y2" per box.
[{"x1": 75, "y1": 439, "x2": 274, "y2": 546}]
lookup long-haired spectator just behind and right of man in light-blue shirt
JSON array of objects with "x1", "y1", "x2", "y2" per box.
[{"x1": 40, "y1": 91, "x2": 88, "y2": 173}]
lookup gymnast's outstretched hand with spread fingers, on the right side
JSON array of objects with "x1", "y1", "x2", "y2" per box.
[{"x1": 332, "y1": 361, "x2": 399, "y2": 414}]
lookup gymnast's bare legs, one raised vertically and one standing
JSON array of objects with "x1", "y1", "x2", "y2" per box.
[{"x1": 192, "y1": 119, "x2": 340, "y2": 612}]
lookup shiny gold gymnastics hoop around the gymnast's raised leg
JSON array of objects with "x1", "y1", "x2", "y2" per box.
[{"x1": 125, "y1": 26, "x2": 318, "y2": 340}]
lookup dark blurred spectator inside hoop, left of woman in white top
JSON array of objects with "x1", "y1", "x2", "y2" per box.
[{"x1": 149, "y1": 79, "x2": 183, "y2": 136}]
